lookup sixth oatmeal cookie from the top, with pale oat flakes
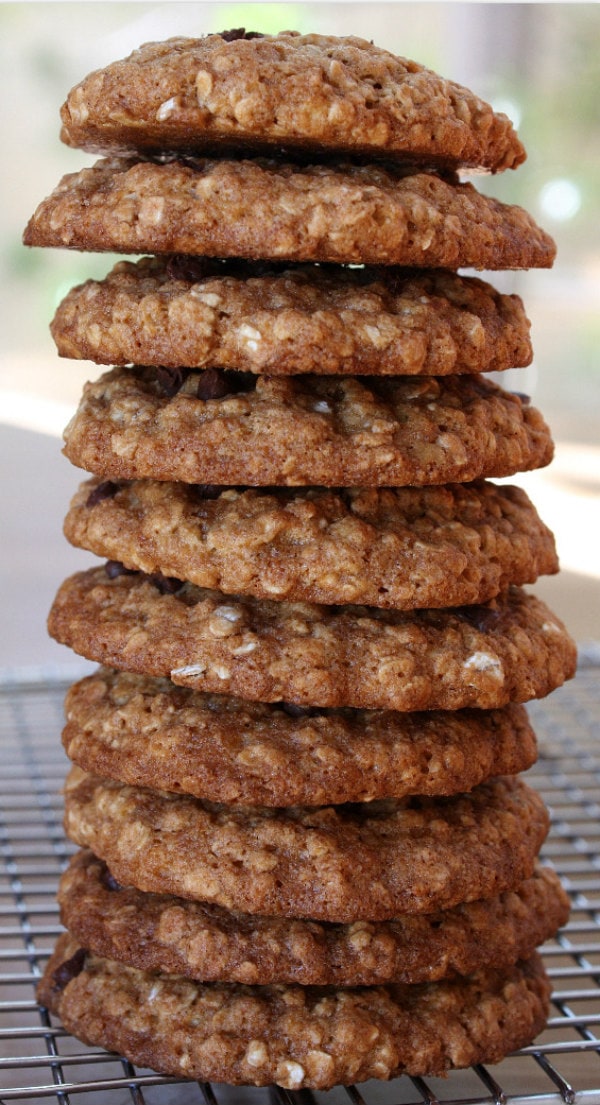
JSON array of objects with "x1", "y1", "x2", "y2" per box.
[{"x1": 49, "y1": 564, "x2": 576, "y2": 711}]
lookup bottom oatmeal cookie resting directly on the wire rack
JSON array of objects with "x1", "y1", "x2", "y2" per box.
[{"x1": 38, "y1": 935, "x2": 550, "y2": 1090}]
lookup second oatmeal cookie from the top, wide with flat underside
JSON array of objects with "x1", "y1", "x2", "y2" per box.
[{"x1": 24, "y1": 158, "x2": 556, "y2": 269}]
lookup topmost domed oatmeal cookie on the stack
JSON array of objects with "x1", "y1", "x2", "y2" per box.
[{"x1": 61, "y1": 30, "x2": 525, "y2": 172}]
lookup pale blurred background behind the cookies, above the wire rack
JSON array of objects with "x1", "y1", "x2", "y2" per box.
[{"x1": 0, "y1": 0, "x2": 600, "y2": 677}]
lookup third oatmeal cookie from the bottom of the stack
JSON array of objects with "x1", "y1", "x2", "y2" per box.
[{"x1": 64, "y1": 767, "x2": 549, "y2": 923}]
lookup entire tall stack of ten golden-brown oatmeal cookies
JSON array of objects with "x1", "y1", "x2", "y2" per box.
[{"x1": 25, "y1": 31, "x2": 575, "y2": 1088}]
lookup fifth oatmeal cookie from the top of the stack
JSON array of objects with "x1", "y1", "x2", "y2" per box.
[{"x1": 64, "y1": 480, "x2": 558, "y2": 609}]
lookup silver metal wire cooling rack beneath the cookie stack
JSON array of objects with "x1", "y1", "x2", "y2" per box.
[{"x1": 0, "y1": 654, "x2": 600, "y2": 1105}]
